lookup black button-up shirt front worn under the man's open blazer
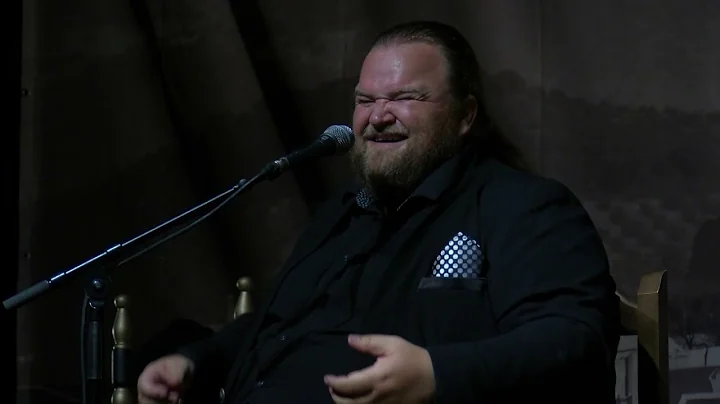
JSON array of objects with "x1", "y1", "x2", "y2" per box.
[{"x1": 239, "y1": 149, "x2": 468, "y2": 404}]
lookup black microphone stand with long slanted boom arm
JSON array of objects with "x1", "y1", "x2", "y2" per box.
[{"x1": 3, "y1": 174, "x2": 262, "y2": 404}]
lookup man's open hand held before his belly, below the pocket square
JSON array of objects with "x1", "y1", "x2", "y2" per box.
[{"x1": 325, "y1": 335, "x2": 435, "y2": 404}]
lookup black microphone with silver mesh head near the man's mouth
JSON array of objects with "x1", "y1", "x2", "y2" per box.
[{"x1": 259, "y1": 125, "x2": 355, "y2": 180}]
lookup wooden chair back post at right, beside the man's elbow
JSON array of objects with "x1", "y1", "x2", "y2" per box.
[{"x1": 616, "y1": 271, "x2": 670, "y2": 404}]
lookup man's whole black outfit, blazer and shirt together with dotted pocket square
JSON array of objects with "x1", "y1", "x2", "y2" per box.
[{"x1": 179, "y1": 143, "x2": 618, "y2": 404}]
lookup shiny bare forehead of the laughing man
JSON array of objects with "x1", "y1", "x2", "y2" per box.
[{"x1": 357, "y1": 42, "x2": 447, "y2": 93}]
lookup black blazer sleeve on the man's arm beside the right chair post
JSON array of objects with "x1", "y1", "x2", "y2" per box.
[{"x1": 428, "y1": 175, "x2": 619, "y2": 404}]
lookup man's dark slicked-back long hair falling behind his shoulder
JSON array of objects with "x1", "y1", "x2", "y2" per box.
[{"x1": 372, "y1": 21, "x2": 530, "y2": 171}]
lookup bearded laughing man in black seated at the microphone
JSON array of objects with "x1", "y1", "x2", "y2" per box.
[{"x1": 138, "y1": 22, "x2": 618, "y2": 404}]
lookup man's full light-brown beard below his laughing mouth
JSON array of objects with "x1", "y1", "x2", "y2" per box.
[{"x1": 350, "y1": 119, "x2": 464, "y2": 209}]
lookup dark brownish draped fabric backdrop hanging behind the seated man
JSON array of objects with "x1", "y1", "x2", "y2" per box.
[{"x1": 9, "y1": 0, "x2": 720, "y2": 403}]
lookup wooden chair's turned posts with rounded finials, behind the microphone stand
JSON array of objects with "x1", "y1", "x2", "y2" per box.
[{"x1": 110, "y1": 276, "x2": 253, "y2": 404}]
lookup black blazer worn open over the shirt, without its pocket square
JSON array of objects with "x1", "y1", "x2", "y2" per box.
[{"x1": 182, "y1": 159, "x2": 619, "y2": 404}]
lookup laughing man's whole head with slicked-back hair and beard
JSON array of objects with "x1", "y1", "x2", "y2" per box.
[{"x1": 351, "y1": 22, "x2": 484, "y2": 204}]
